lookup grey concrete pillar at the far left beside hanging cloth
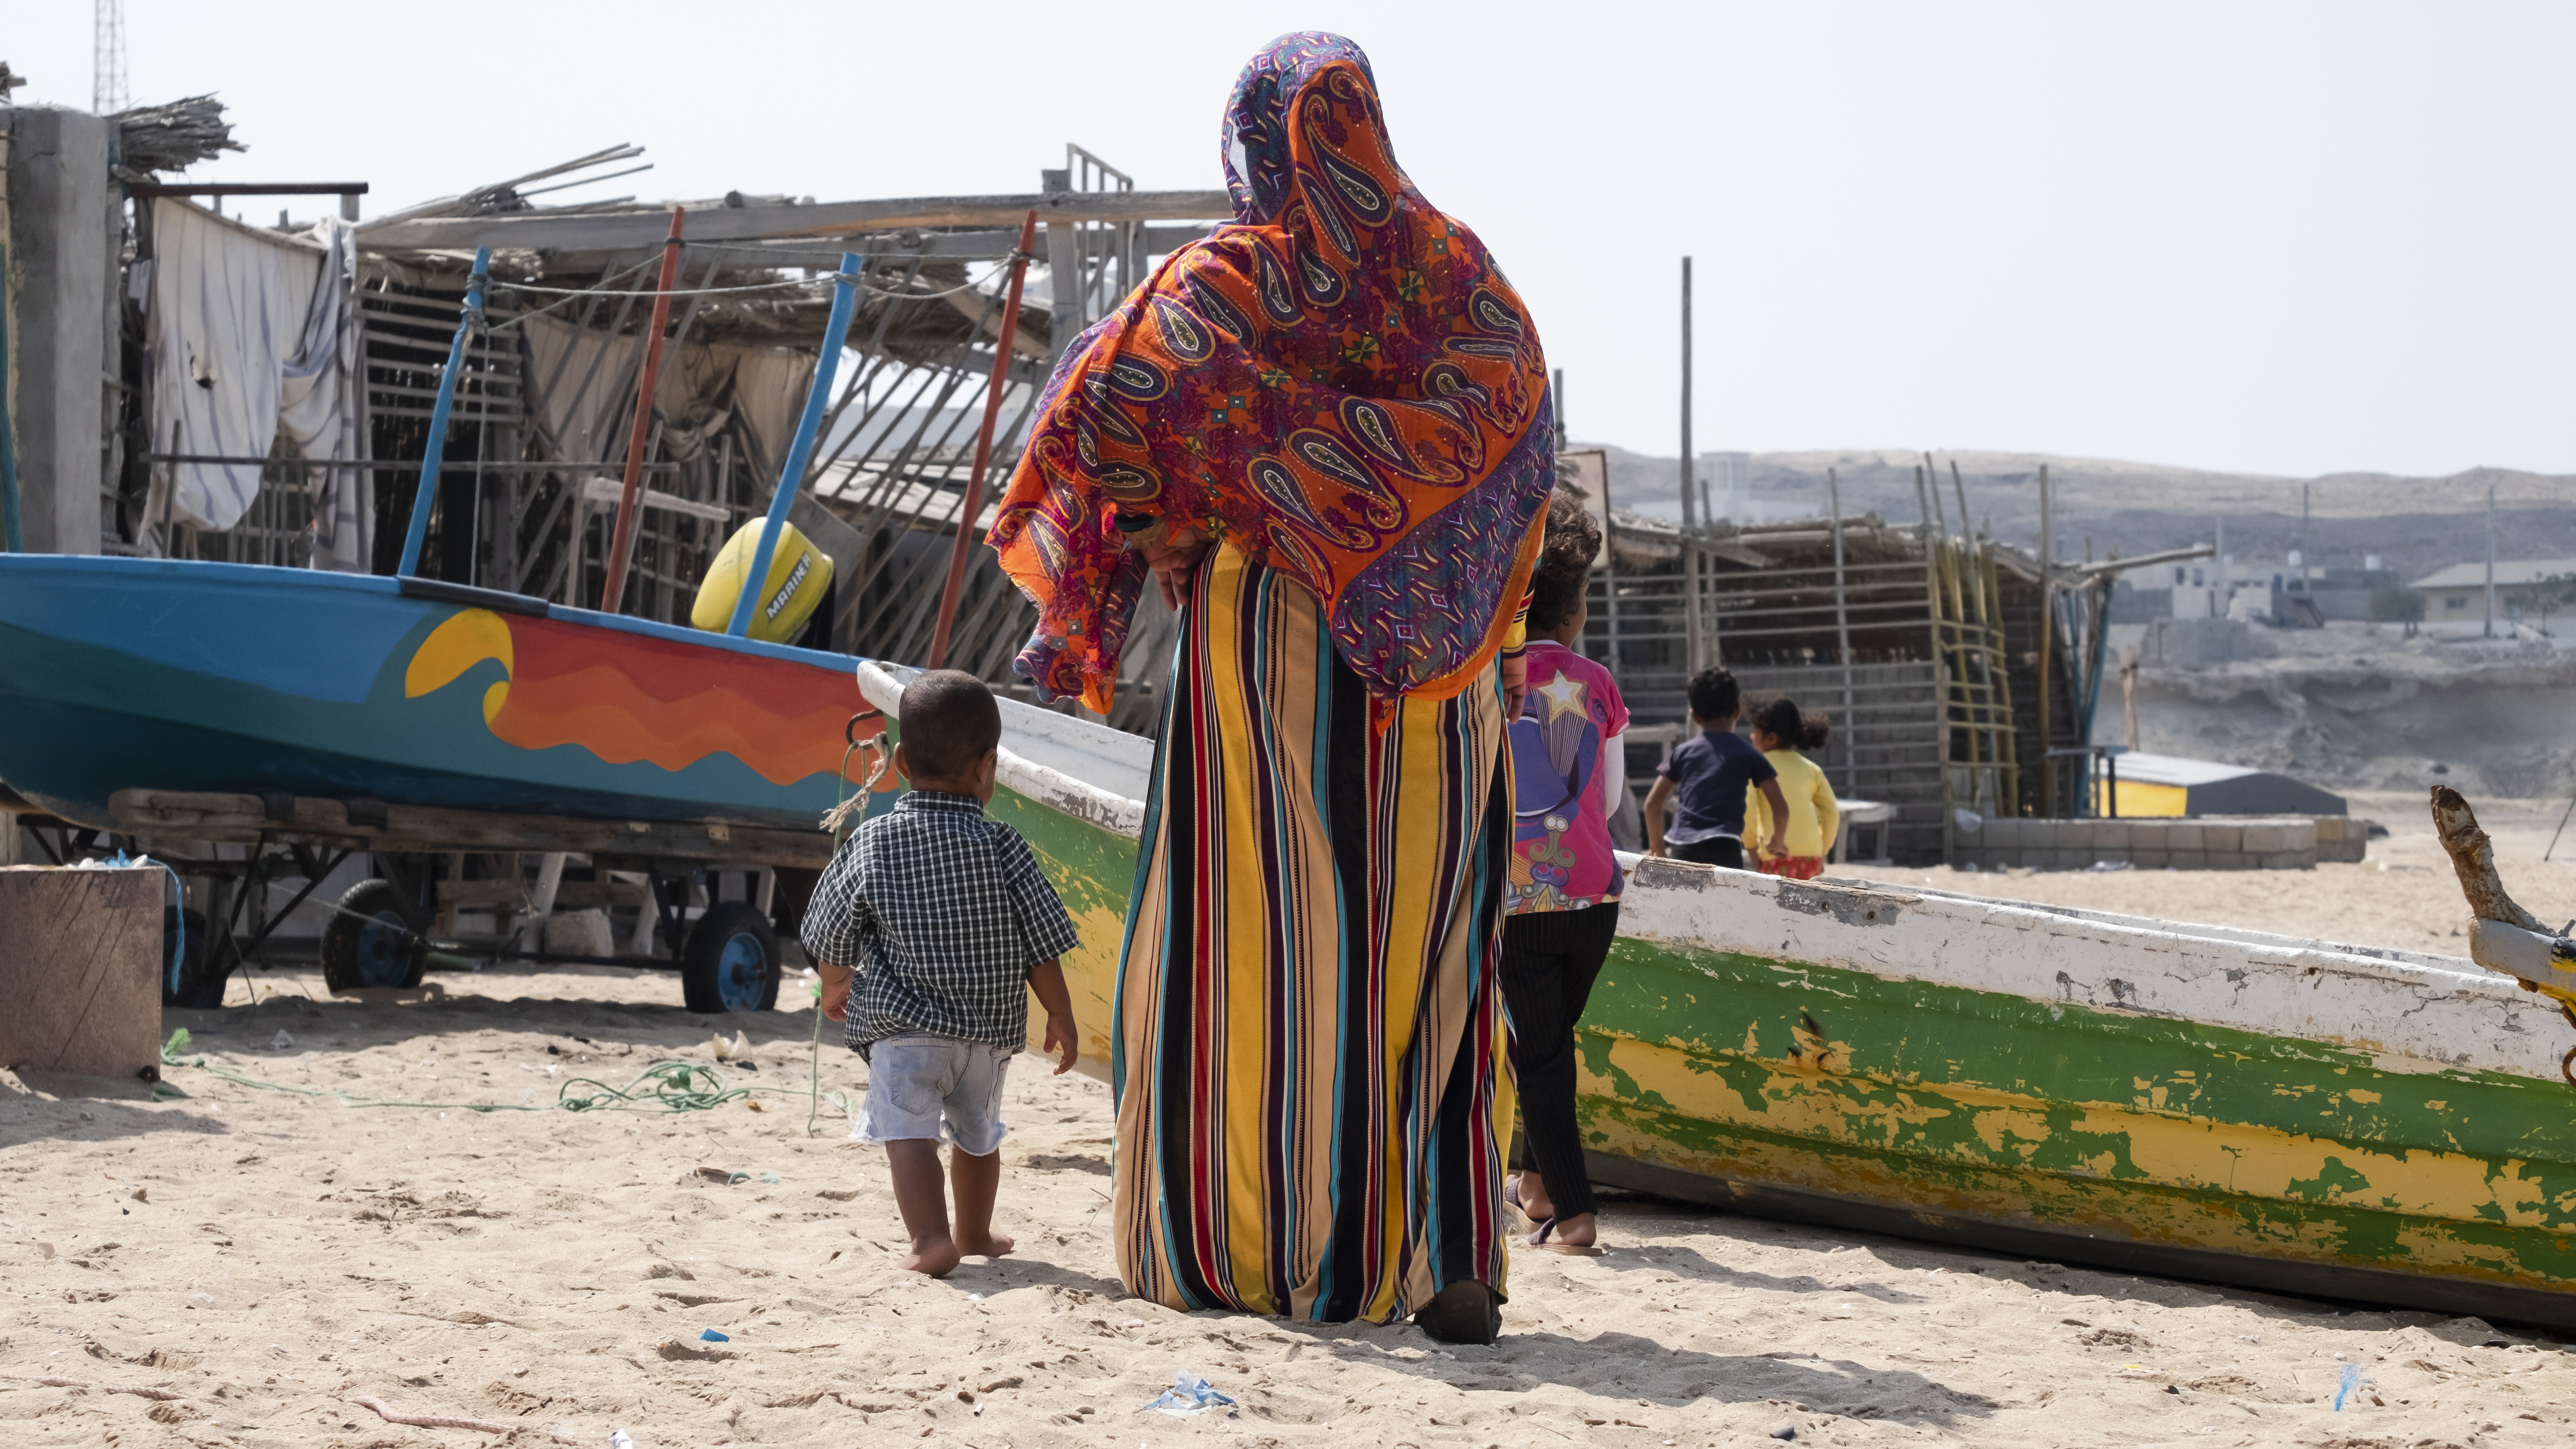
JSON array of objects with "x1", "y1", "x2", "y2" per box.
[{"x1": 8, "y1": 105, "x2": 124, "y2": 553}]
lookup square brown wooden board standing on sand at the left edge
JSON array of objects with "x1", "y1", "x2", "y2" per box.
[{"x1": 0, "y1": 865, "x2": 170, "y2": 1079}]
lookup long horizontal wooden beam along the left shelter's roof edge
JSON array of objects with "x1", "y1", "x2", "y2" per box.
[{"x1": 358, "y1": 190, "x2": 1234, "y2": 252}]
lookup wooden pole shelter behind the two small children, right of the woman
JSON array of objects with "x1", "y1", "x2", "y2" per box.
[{"x1": 1584, "y1": 481, "x2": 2100, "y2": 865}]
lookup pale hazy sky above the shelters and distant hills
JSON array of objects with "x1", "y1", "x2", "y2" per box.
[{"x1": 0, "y1": 0, "x2": 2576, "y2": 476}]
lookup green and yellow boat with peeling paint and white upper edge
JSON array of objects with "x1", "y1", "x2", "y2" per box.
[{"x1": 860, "y1": 667, "x2": 2576, "y2": 1328}]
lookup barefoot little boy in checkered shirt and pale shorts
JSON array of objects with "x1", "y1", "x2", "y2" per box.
[{"x1": 801, "y1": 669, "x2": 1079, "y2": 1277}]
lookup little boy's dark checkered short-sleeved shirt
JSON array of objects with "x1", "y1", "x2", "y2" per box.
[{"x1": 801, "y1": 790, "x2": 1082, "y2": 1055}]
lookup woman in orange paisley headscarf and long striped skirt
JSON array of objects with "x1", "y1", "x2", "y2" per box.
[{"x1": 992, "y1": 33, "x2": 1553, "y2": 1341}]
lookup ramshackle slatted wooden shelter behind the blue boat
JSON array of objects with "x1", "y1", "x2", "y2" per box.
[{"x1": 116, "y1": 147, "x2": 1231, "y2": 728}]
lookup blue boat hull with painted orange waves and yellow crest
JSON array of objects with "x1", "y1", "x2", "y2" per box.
[{"x1": 0, "y1": 553, "x2": 866, "y2": 829}]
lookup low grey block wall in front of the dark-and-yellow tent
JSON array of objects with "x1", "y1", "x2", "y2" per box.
[{"x1": 1950, "y1": 816, "x2": 2370, "y2": 870}]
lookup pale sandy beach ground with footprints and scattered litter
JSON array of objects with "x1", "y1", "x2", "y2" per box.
[{"x1": 0, "y1": 800, "x2": 2576, "y2": 1449}]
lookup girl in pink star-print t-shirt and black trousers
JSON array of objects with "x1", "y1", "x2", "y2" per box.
[{"x1": 1502, "y1": 491, "x2": 1628, "y2": 1245}]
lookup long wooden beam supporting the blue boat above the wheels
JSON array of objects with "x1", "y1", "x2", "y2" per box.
[{"x1": 108, "y1": 790, "x2": 832, "y2": 867}]
